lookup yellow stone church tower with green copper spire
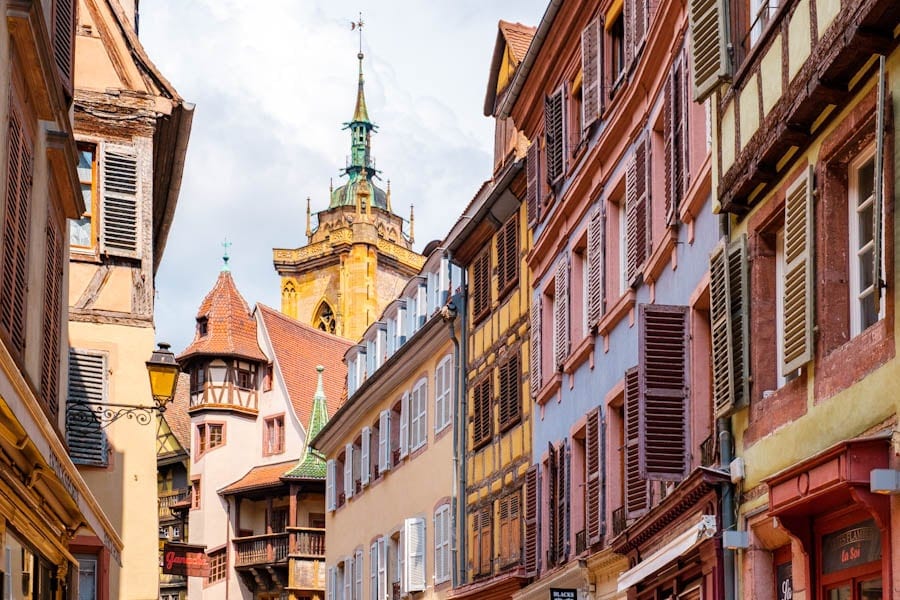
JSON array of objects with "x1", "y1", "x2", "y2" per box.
[{"x1": 273, "y1": 51, "x2": 425, "y2": 340}]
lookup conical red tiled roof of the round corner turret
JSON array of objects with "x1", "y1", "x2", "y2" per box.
[{"x1": 178, "y1": 271, "x2": 268, "y2": 362}]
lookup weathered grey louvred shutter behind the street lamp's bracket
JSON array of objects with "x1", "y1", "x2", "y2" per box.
[{"x1": 66, "y1": 348, "x2": 107, "y2": 466}]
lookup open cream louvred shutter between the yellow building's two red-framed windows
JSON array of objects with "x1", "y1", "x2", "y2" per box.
[{"x1": 783, "y1": 166, "x2": 815, "y2": 373}]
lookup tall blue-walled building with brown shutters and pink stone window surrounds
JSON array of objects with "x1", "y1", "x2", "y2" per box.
[{"x1": 500, "y1": 0, "x2": 727, "y2": 599}]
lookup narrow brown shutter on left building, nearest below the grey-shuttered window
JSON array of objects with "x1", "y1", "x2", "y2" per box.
[{"x1": 41, "y1": 216, "x2": 63, "y2": 423}]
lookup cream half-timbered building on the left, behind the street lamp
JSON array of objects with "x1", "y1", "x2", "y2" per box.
[{"x1": 63, "y1": 0, "x2": 193, "y2": 598}]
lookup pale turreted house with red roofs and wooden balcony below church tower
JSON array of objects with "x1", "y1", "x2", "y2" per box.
[{"x1": 178, "y1": 267, "x2": 349, "y2": 600}]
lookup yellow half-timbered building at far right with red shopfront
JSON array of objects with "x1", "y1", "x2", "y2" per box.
[{"x1": 690, "y1": 0, "x2": 900, "y2": 599}]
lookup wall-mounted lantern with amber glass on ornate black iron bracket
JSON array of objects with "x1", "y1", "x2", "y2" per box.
[{"x1": 66, "y1": 342, "x2": 179, "y2": 429}]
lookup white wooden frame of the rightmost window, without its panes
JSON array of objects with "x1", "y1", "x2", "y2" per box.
[{"x1": 847, "y1": 147, "x2": 885, "y2": 337}]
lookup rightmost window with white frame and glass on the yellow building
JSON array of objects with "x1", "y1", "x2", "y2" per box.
[{"x1": 848, "y1": 150, "x2": 885, "y2": 335}]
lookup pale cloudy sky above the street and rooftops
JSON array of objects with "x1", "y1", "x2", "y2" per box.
[{"x1": 139, "y1": 0, "x2": 547, "y2": 353}]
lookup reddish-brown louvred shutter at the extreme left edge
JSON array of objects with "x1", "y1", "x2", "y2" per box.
[{"x1": 0, "y1": 106, "x2": 32, "y2": 353}]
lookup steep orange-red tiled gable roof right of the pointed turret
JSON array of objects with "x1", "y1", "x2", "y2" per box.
[{"x1": 256, "y1": 304, "x2": 353, "y2": 428}]
